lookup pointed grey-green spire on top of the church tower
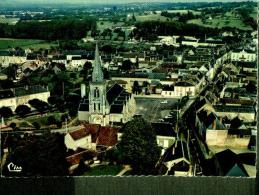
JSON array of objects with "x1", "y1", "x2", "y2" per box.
[{"x1": 92, "y1": 43, "x2": 103, "y2": 82}]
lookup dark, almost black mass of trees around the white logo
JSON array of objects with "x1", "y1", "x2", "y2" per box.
[{"x1": 3, "y1": 133, "x2": 69, "y2": 176}]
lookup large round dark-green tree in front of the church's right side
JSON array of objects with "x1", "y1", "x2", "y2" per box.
[{"x1": 118, "y1": 117, "x2": 161, "y2": 175}]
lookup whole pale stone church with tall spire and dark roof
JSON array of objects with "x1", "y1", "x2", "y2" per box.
[{"x1": 78, "y1": 44, "x2": 136, "y2": 126}]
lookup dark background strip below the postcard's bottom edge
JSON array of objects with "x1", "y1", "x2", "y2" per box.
[{"x1": 0, "y1": 176, "x2": 256, "y2": 195}]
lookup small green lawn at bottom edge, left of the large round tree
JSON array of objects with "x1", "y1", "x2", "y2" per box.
[{"x1": 84, "y1": 165, "x2": 123, "y2": 176}]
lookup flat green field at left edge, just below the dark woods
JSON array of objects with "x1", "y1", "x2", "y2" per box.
[{"x1": 0, "y1": 38, "x2": 56, "y2": 49}]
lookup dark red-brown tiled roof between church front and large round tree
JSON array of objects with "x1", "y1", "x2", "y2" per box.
[{"x1": 96, "y1": 127, "x2": 117, "y2": 146}]
